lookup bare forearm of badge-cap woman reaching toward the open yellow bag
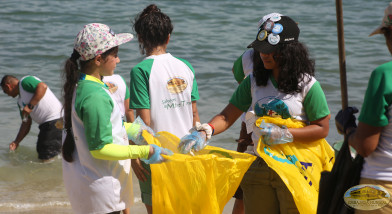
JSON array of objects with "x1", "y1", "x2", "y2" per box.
[{"x1": 210, "y1": 103, "x2": 243, "y2": 135}]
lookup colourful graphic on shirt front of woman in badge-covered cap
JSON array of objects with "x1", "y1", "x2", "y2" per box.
[{"x1": 253, "y1": 96, "x2": 291, "y2": 119}]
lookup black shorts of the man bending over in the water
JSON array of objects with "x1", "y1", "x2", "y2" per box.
[{"x1": 37, "y1": 119, "x2": 62, "y2": 160}]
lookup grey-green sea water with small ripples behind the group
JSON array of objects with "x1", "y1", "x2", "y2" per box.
[{"x1": 0, "y1": 0, "x2": 391, "y2": 213}]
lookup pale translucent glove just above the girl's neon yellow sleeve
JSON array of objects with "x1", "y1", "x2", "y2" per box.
[{"x1": 124, "y1": 117, "x2": 155, "y2": 145}]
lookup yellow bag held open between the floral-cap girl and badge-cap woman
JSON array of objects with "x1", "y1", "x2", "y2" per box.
[{"x1": 143, "y1": 131, "x2": 256, "y2": 214}]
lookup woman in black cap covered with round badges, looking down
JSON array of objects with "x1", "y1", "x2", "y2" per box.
[{"x1": 180, "y1": 13, "x2": 330, "y2": 213}]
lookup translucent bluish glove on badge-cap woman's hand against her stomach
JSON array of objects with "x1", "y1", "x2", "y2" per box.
[{"x1": 254, "y1": 120, "x2": 293, "y2": 146}]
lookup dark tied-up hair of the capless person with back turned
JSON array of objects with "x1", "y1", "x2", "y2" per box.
[{"x1": 133, "y1": 4, "x2": 173, "y2": 55}]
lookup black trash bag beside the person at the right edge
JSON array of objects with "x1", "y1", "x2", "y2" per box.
[{"x1": 317, "y1": 134, "x2": 363, "y2": 214}]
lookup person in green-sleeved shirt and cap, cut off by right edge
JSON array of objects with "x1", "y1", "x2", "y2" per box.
[{"x1": 335, "y1": 2, "x2": 392, "y2": 213}]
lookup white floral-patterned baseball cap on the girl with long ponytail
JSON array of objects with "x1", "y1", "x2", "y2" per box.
[{"x1": 74, "y1": 23, "x2": 133, "y2": 61}]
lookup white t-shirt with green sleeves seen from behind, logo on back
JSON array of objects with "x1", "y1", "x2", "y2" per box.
[{"x1": 130, "y1": 53, "x2": 199, "y2": 138}]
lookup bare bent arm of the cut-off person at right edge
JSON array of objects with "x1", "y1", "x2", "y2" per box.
[{"x1": 346, "y1": 122, "x2": 384, "y2": 157}]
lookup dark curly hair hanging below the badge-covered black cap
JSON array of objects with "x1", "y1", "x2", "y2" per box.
[{"x1": 253, "y1": 42, "x2": 315, "y2": 94}]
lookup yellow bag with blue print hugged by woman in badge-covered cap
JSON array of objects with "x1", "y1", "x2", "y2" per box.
[{"x1": 256, "y1": 117, "x2": 335, "y2": 214}]
